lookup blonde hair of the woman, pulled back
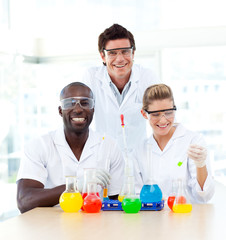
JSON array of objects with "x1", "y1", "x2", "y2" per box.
[{"x1": 142, "y1": 84, "x2": 175, "y2": 110}]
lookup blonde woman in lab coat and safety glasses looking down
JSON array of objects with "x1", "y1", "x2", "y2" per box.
[{"x1": 133, "y1": 84, "x2": 214, "y2": 203}]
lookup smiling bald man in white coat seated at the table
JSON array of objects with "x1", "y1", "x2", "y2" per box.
[{"x1": 17, "y1": 82, "x2": 124, "y2": 213}]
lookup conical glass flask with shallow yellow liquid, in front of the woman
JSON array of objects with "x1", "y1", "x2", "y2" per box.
[{"x1": 173, "y1": 179, "x2": 192, "y2": 213}]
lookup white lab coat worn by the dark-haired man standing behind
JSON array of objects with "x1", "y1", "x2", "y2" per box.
[{"x1": 83, "y1": 64, "x2": 159, "y2": 152}]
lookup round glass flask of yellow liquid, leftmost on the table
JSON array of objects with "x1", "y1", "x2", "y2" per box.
[{"x1": 59, "y1": 176, "x2": 83, "y2": 212}]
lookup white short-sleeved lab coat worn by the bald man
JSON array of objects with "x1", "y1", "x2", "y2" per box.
[{"x1": 17, "y1": 128, "x2": 124, "y2": 195}]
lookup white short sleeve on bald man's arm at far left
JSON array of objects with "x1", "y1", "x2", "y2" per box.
[{"x1": 17, "y1": 138, "x2": 48, "y2": 185}]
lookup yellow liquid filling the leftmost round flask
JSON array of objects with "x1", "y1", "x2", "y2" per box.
[{"x1": 60, "y1": 192, "x2": 83, "y2": 212}]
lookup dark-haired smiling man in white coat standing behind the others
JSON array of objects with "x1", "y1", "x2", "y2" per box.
[{"x1": 83, "y1": 24, "x2": 159, "y2": 151}]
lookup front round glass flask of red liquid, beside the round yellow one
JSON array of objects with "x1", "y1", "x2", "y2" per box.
[{"x1": 83, "y1": 182, "x2": 102, "y2": 213}]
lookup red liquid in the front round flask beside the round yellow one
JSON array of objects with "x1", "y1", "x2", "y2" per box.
[{"x1": 83, "y1": 193, "x2": 102, "y2": 213}]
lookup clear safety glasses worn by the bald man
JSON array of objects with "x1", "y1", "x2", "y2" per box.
[{"x1": 60, "y1": 97, "x2": 94, "y2": 110}]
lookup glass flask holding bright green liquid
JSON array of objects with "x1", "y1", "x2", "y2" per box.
[{"x1": 122, "y1": 176, "x2": 141, "y2": 213}]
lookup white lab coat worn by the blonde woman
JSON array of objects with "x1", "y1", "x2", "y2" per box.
[{"x1": 132, "y1": 124, "x2": 214, "y2": 203}]
